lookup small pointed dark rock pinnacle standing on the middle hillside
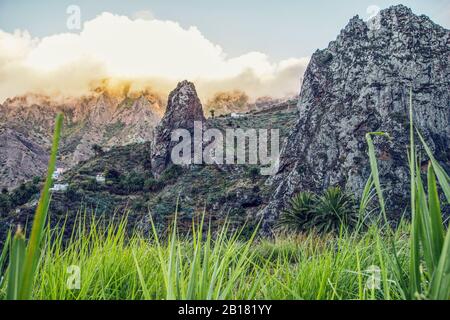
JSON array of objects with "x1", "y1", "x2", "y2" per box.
[{"x1": 151, "y1": 80, "x2": 205, "y2": 176}]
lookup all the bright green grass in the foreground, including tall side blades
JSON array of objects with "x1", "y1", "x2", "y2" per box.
[{"x1": 0, "y1": 89, "x2": 450, "y2": 300}]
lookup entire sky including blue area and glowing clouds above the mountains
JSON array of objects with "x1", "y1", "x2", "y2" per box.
[{"x1": 0, "y1": 0, "x2": 450, "y2": 103}]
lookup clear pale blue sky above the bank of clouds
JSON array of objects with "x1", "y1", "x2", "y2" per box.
[{"x1": 0, "y1": 0, "x2": 450, "y2": 59}]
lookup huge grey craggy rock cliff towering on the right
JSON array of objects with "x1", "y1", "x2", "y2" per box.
[{"x1": 260, "y1": 6, "x2": 450, "y2": 229}]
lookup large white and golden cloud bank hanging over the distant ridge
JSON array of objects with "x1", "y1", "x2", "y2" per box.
[{"x1": 0, "y1": 13, "x2": 309, "y2": 101}]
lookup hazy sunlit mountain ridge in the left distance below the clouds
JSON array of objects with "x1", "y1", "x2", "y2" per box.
[{"x1": 0, "y1": 92, "x2": 164, "y2": 188}]
